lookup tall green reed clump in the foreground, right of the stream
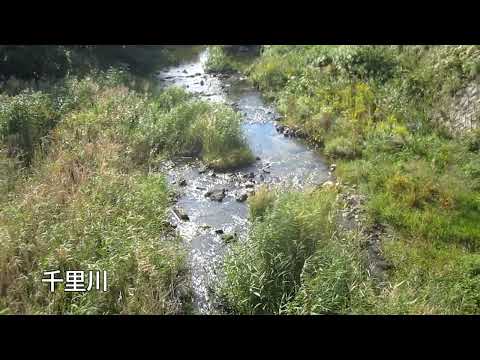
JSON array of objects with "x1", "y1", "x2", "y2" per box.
[{"x1": 220, "y1": 189, "x2": 375, "y2": 314}]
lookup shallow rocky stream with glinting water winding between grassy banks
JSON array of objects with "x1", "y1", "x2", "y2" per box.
[{"x1": 158, "y1": 50, "x2": 329, "y2": 314}]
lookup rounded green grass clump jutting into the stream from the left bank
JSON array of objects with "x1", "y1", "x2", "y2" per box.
[{"x1": 139, "y1": 88, "x2": 254, "y2": 170}]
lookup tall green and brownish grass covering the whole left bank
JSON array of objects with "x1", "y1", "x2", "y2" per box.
[{"x1": 0, "y1": 61, "x2": 251, "y2": 314}]
